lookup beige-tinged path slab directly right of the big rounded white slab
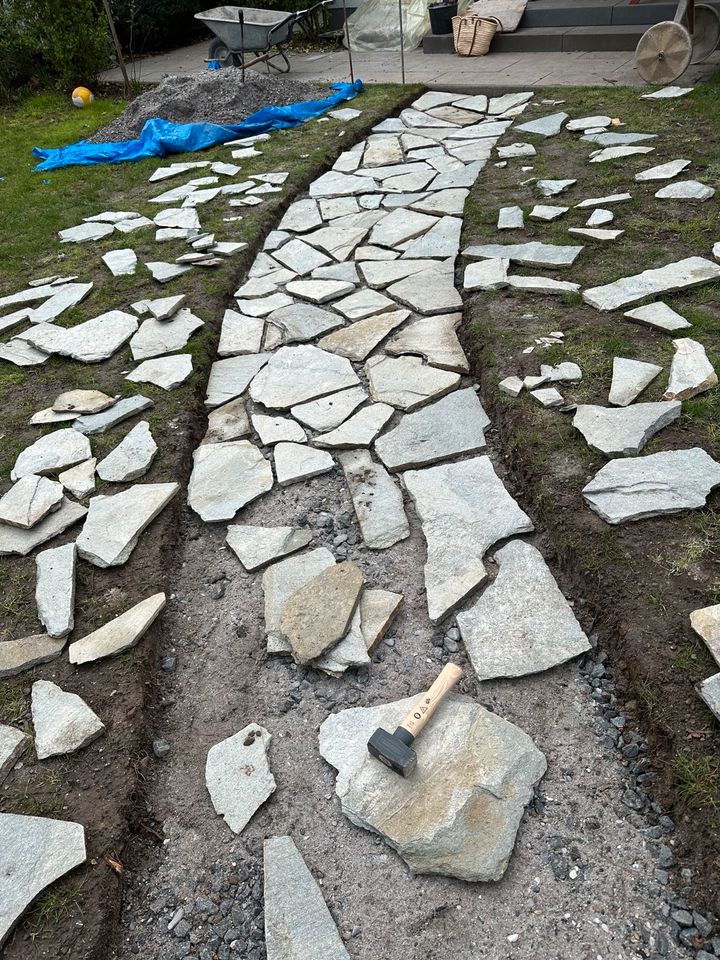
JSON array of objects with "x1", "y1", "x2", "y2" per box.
[{"x1": 365, "y1": 356, "x2": 460, "y2": 411}]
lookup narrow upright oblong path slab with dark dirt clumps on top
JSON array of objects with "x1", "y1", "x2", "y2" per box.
[{"x1": 338, "y1": 450, "x2": 410, "y2": 550}]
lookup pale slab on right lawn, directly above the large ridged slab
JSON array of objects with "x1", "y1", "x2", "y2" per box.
[{"x1": 573, "y1": 400, "x2": 682, "y2": 457}]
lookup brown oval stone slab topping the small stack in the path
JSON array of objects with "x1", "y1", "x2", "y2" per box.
[{"x1": 280, "y1": 561, "x2": 363, "y2": 663}]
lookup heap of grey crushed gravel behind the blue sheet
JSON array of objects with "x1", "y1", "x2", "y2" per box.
[{"x1": 89, "y1": 68, "x2": 329, "y2": 143}]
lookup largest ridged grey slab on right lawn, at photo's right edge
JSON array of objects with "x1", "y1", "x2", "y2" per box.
[{"x1": 583, "y1": 447, "x2": 720, "y2": 524}]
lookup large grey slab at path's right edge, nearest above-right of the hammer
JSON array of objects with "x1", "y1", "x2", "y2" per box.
[{"x1": 457, "y1": 540, "x2": 591, "y2": 680}]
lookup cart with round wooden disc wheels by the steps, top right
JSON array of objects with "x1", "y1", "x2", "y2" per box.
[{"x1": 631, "y1": 0, "x2": 720, "y2": 83}]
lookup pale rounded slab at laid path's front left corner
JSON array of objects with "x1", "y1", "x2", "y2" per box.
[{"x1": 188, "y1": 440, "x2": 273, "y2": 522}]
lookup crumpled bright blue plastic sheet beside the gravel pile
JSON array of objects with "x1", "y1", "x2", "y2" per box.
[{"x1": 33, "y1": 80, "x2": 363, "y2": 170}]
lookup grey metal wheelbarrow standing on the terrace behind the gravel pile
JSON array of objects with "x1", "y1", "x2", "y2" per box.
[{"x1": 195, "y1": 0, "x2": 332, "y2": 80}]
